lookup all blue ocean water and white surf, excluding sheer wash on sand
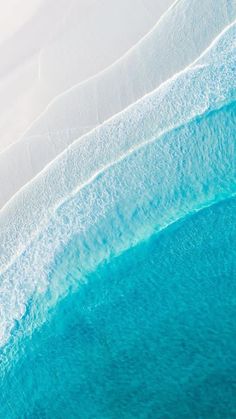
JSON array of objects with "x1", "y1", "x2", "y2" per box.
[{"x1": 0, "y1": 13, "x2": 236, "y2": 419}]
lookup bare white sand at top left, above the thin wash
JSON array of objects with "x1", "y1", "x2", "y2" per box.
[{"x1": 0, "y1": 0, "x2": 172, "y2": 150}]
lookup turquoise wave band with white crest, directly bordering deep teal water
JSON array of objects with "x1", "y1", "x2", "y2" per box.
[{"x1": 1, "y1": 96, "x2": 236, "y2": 344}]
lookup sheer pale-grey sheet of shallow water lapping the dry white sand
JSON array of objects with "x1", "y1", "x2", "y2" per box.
[{"x1": 0, "y1": 0, "x2": 233, "y2": 210}]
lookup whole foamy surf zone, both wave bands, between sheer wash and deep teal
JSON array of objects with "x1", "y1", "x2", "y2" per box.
[{"x1": 0, "y1": 18, "x2": 236, "y2": 345}]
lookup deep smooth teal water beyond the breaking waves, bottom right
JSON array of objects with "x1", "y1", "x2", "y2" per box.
[{"x1": 0, "y1": 199, "x2": 236, "y2": 419}]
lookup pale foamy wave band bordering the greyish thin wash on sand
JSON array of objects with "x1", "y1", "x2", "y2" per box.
[{"x1": 0, "y1": 24, "x2": 235, "y2": 271}]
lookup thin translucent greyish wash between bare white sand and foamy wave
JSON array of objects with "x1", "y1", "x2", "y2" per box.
[{"x1": 0, "y1": 0, "x2": 236, "y2": 205}]
